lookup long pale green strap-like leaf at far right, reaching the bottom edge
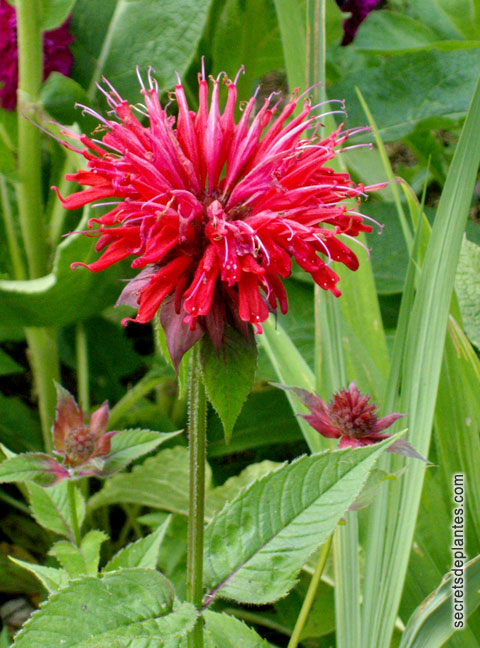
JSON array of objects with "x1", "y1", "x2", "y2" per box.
[{"x1": 363, "y1": 71, "x2": 480, "y2": 648}]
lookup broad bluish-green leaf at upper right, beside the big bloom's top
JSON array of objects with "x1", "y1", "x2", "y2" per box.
[{"x1": 329, "y1": 48, "x2": 480, "y2": 142}]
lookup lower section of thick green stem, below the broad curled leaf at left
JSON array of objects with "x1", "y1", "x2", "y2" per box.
[{"x1": 25, "y1": 328, "x2": 60, "y2": 452}]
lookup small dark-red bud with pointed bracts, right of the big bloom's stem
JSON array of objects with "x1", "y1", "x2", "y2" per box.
[{"x1": 276, "y1": 382, "x2": 425, "y2": 461}]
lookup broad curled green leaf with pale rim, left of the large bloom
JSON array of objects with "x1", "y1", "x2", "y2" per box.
[{"x1": 0, "y1": 210, "x2": 125, "y2": 327}]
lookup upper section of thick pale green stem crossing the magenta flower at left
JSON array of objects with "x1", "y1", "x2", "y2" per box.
[{"x1": 16, "y1": 0, "x2": 47, "y2": 278}]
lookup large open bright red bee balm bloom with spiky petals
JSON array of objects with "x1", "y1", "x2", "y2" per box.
[{"x1": 56, "y1": 73, "x2": 376, "y2": 362}]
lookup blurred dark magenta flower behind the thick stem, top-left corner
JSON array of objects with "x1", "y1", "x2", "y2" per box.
[{"x1": 0, "y1": 0, "x2": 73, "y2": 110}]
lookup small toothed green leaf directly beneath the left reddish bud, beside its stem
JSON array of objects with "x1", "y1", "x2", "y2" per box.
[{"x1": 27, "y1": 480, "x2": 85, "y2": 542}]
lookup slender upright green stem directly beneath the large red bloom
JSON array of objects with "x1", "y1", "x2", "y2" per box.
[{"x1": 187, "y1": 344, "x2": 206, "y2": 648}]
